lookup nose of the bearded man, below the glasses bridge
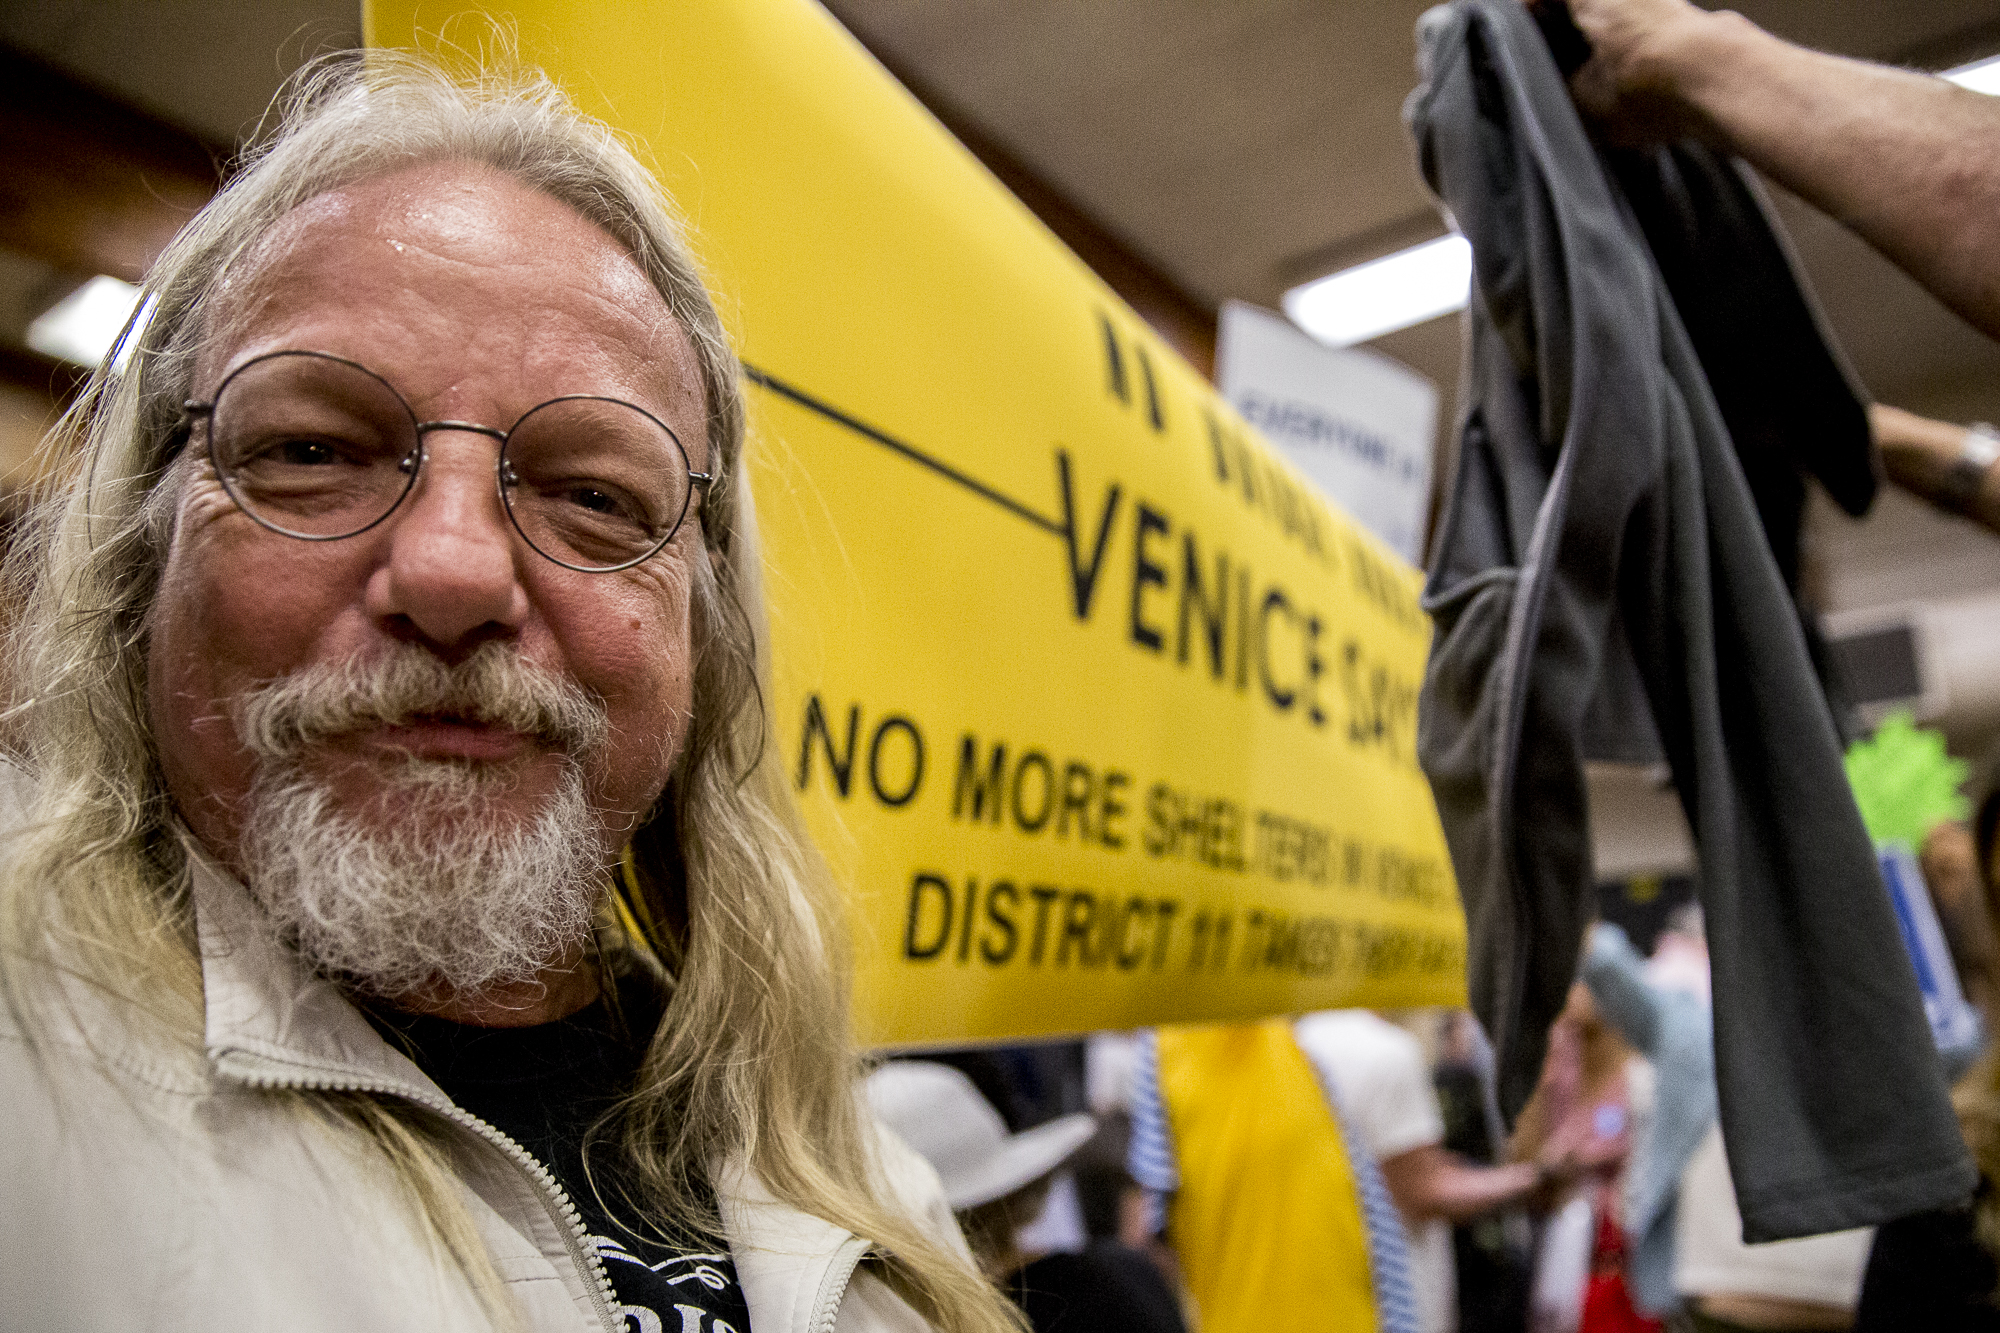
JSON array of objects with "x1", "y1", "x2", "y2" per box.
[{"x1": 368, "y1": 430, "x2": 528, "y2": 652}]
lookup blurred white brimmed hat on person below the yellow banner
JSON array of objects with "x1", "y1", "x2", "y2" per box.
[{"x1": 868, "y1": 1061, "x2": 1098, "y2": 1213}]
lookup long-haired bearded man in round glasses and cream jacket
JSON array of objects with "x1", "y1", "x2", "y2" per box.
[{"x1": 0, "y1": 56, "x2": 1006, "y2": 1333}]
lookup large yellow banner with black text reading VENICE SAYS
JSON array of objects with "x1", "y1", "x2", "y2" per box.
[{"x1": 366, "y1": 0, "x2": 1464, "y2": 1045}]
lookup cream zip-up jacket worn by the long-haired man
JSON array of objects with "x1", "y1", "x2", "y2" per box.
[{"x1": 0, "y1": 836, "x2": 970, "y2": 1333}]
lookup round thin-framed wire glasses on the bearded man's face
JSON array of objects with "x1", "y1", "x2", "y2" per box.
[{"x1": 182, "y1": 350, "x2": 712, "y2": 572}]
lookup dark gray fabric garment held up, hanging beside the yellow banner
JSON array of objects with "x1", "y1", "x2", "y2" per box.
[{"x1": 1408, "y1": 0, "x2": 1974, "y2": 1241}]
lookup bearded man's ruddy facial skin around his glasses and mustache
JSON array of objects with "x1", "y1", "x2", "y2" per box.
[{"x1": 148, "y1": 164, "x2": 708, "y2": 892}]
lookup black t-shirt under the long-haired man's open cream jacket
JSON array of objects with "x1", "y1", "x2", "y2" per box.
[{"x1": 370, "y1": 964, "x2": 750, "y2": 1333}]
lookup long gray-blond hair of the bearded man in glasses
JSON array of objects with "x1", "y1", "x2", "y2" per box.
[{"x1": 0, "y1": 54, "x2": 1012, "y2": 1333}]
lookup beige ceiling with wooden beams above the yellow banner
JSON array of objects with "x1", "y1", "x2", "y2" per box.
[{"x1": 11, "y1": 0, "x2": 2000, "y2": 608}]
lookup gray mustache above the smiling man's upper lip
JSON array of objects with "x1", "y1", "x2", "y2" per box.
[{"x1": 232, "y1": 642, "x2": 610, "y2": 761}]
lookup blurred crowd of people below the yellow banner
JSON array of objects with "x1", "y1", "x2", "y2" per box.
[{"x1": 870, "y1": 868, "x2": 2000, "y2": 1333}]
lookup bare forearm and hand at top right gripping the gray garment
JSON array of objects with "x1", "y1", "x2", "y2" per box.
[{"x1": 1570, "y1": 0, "x2": 2000, "y2": 336}]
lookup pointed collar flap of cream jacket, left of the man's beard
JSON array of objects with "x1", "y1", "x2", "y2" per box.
[{"x1": 184, "y1": 837, "x2": 444, "y2": 1103}]
